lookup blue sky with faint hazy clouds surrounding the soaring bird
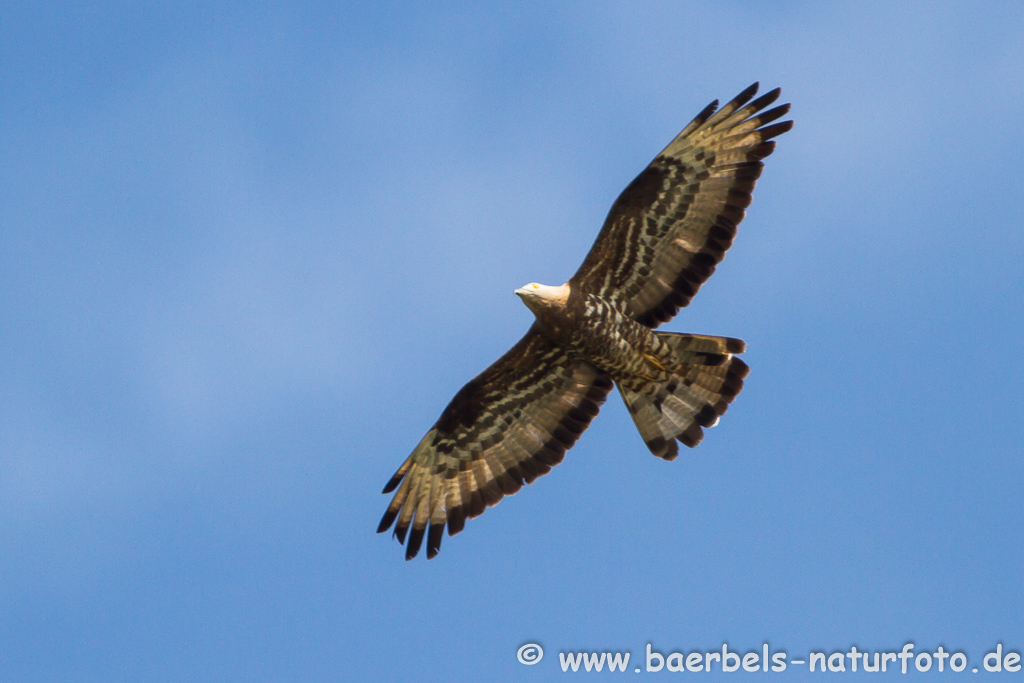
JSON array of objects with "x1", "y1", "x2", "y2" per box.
[{"x1": 0, "y1": 2, "x2": 1024, "y2": 681}]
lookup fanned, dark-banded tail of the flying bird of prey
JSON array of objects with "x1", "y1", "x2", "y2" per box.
[{"x1": 618, "y1": 332, "x2": 750, "y2": 460}]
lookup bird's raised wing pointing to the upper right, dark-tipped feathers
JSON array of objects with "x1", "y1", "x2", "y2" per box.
[{"x1": 569, "y1": 83, "x2": 793, "y2": 328}]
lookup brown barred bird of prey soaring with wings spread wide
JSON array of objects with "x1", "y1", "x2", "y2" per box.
[{"x1": 377, "y1": 83, "x2": 793, "y2": 560}]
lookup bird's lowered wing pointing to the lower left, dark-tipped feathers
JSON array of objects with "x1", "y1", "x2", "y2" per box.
[{"x1": 377, "y1": 328, "x2": 612, "y2": 559}]
